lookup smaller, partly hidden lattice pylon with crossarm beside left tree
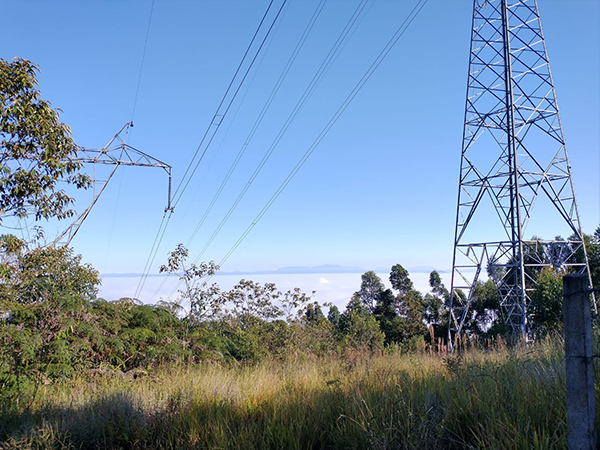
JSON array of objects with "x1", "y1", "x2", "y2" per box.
[{"x1": 52, "y1": 122, "x2": 172, "y2": 245}]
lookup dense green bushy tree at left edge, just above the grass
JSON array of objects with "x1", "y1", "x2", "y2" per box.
[{"x1": 0, "y1": 235, "x2": 100, "y2": 404}]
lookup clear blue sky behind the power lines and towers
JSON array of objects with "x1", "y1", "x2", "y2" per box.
[{"x1": 0, "y1": 0, "x2": 600, "y2": 308}]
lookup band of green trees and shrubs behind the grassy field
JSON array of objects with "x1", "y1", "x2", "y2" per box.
[{"x1": 0, "y1": 228, "x2": 600, "y2": 404}]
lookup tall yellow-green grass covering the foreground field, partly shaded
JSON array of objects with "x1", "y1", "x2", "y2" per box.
[{"x1": 0, "y1": 339, "x2": 600, "y2": 450}]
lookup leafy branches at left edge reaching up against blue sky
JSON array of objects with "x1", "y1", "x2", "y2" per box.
[{"x1": 0, "y1": 58, "x2": 91, "y2": 221}]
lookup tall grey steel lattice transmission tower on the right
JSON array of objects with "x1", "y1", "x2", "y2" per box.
[{"x1": 448, "y1": 0, "x2": 595, "y2": 342}]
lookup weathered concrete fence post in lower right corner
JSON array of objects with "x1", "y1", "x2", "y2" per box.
[{"x1": 563, "y1": 274, "x2": 596, "y2": 450}]
